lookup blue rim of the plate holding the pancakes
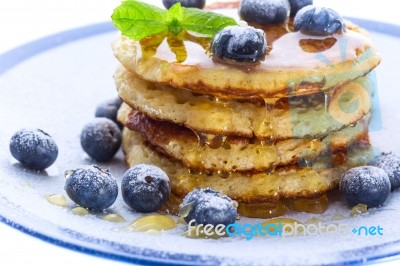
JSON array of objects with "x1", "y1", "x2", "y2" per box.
[{"x1": 0, "y1": 18, "x2": 400, "y2": 265}]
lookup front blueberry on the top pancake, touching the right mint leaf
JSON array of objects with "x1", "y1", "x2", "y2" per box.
[{"x1": 211, "y1": 26, "x2": 267, "y2": 63}]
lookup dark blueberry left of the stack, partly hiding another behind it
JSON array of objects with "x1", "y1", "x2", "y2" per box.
[{"x1": 81, "y1": 118, "x2": 121, "y2": 162}]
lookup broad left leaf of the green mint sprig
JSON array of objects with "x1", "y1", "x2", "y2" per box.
[{"x1": 111, "y1": 0, "x2": 168, "y2": 41}]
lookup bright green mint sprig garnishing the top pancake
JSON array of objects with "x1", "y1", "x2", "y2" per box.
[{"x1": 111, "y1": 0, "x2": 237, "y2": 41}]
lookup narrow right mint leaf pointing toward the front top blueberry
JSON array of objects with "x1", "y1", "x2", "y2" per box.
[{"x1": 181, "y1": 8, "x2": 237, "y2": 36}]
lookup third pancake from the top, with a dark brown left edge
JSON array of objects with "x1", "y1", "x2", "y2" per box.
[{"x1": 118, "y1": 105, "x2": 369, "y2": 173}]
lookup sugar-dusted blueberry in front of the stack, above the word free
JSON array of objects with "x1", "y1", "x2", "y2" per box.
[{"x1": 180, "y1": 188, "x2": 237, "y2": 226}]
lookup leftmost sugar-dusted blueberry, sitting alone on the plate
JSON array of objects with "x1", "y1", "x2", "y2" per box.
[{"x1": 10, "y1": 129, "x2": 58, "y2": 171}]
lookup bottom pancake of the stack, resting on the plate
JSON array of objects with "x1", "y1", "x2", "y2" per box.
[{"x1": 123, "y1": 128, "x2": 371, "y2": 204}]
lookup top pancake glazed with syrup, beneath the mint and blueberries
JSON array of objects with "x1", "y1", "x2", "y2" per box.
[{"x1": 113, "y1": 16, "x2": 380, "y2": 99}]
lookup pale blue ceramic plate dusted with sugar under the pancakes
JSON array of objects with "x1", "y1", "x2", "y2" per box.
[{"x1": 0, "y1": 20, "x2": 400, "y2": 264}]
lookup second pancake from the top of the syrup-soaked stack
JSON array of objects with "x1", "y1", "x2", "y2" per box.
[{"x1": 114, "y1": 68, "x2": 375, "y2": 140}]
